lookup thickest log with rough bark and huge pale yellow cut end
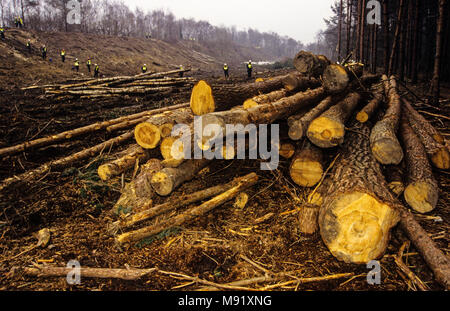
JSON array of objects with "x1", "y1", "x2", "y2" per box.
[{"x1": 319, "y1": 122, "x2": 399, "y2": 264}]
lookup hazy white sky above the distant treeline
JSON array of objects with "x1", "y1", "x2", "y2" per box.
[{"x1": 123, "y1": 0, "x2": 334, "y2": 43}]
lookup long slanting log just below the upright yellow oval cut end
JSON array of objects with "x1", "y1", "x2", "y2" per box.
[{"x1": 192, "y1": 87, "x2": 326, "y2": 150}]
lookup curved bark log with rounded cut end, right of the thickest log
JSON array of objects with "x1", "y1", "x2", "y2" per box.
[{"x1": 401, "y1": 116, "x2": 439, "y2": 213}]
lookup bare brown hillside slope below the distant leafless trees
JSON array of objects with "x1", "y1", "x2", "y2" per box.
[{"x1": 0, "y1": 29, "x2": 270, "y2": 89}]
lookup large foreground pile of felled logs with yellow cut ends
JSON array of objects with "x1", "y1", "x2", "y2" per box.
[{"x1": 0, "y1": 51, "x2": 450, "y2": 289}]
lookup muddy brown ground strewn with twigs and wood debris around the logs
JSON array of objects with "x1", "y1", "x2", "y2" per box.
[{"x1": 0, "y1": 72, "x2": 450, "y2": 291}]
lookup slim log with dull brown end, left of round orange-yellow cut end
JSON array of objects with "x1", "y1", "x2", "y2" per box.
[{"x1": 288, "y1": 96, "x2": 338, "y2": 140}]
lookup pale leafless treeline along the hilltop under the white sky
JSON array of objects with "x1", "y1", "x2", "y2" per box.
[{"x1": 0, "y1": 0, "x2": 303, "y2": 58}]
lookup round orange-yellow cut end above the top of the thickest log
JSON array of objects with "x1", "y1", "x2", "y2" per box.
[{"x1": 307, "y1": 117, "x2": 345, "y2": 148}]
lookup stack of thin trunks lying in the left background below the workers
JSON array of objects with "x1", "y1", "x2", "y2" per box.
[{"x1": 22, "y1": 69, "x2": 194, "y2": 98}]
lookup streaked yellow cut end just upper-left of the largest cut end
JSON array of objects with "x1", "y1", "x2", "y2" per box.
[{"x1": 290, "y1": 158, "x2": 323, "y2": 187}]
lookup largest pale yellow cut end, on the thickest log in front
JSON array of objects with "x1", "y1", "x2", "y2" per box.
[{"x1": 320, "y1": 192, "x2": 398, "y2": 263}]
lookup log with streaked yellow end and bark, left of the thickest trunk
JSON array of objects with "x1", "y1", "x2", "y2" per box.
[{"x1": 289, "y1": 142, "x2": 323, "y2": 187}]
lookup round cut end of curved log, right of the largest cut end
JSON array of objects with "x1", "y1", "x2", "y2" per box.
[{"x1": 404, "y1": 181, "x2": 438, "y2": 213}]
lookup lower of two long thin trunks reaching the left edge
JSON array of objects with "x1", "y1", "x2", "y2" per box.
[{"x1": 0, "y1": 131, "x2": 133, "y2": 191}]
